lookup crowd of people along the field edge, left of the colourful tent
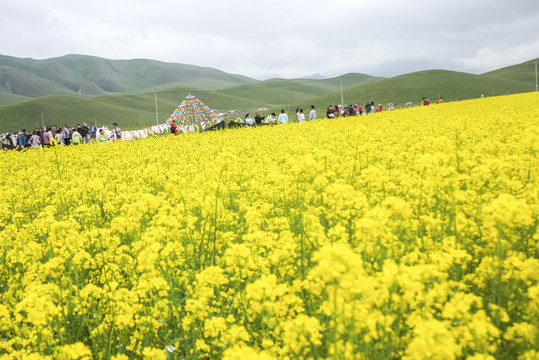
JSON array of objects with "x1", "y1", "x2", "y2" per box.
[{"x1": 0, "y1": 123, "x2": 122, "y2": 150}]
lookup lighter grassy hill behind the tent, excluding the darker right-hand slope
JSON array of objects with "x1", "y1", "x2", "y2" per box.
[{"x1": 0, "y1": 74, "x2": 377, "y2": 131}]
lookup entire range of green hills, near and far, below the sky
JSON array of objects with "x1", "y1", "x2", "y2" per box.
[{"x1": 0, "y1": 55, "x2": 535, "y2": 131}]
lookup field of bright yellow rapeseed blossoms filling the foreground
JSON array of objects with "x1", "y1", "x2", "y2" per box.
[{"x1": 0, "y1": 93, "x2": 539, "y2": 360}]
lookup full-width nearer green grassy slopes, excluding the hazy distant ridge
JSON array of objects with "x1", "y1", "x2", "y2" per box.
[{"x1": 0, "y1": 62, "x2": 535, "y2": 131}]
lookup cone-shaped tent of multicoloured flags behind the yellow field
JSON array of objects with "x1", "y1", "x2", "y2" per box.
[{"x1": 165, "y1": 94, "x2": 223, "y2": 133}]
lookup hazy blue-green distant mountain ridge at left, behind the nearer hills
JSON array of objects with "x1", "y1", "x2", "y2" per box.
[{"x1": 0, "y1": 55, "x2": 258, "y2": 98}]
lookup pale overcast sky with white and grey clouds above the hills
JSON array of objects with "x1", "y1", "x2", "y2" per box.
[{"x1": 0, "y1": 0, "x2": 539, "y2": 79}]
